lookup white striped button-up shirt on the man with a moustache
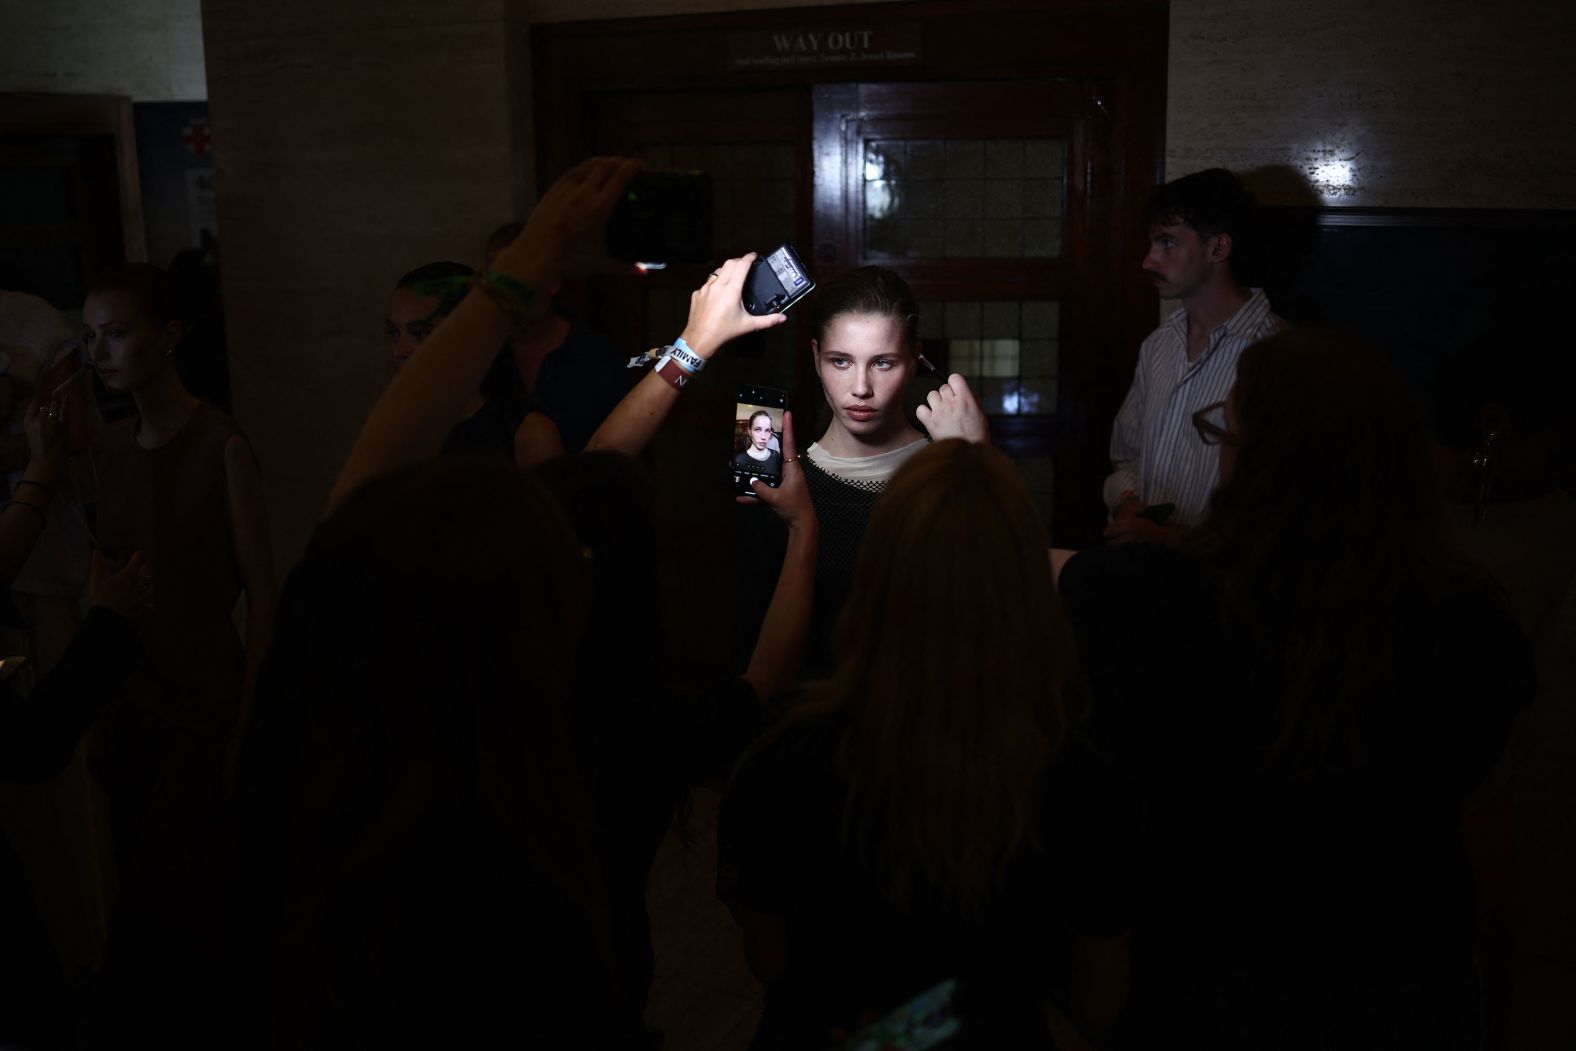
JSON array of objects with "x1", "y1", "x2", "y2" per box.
[{"x1": 1105, "y1": 288, "x2": 1286, "y2": 525}]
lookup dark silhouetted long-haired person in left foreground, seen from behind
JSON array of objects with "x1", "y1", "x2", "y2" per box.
[{"x1": 240, "y1": 459, "x2": 611, "y2": 1040}]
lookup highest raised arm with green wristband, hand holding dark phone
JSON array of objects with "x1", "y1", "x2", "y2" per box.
[{"x1": 328, "y1": 158, "x2": 640, "y2": 512}]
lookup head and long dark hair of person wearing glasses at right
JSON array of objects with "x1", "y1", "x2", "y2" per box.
[{"x1": 1188, "y1": 329, "x2": 1477, "y2": 771}]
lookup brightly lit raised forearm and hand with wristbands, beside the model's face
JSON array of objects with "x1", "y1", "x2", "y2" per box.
[{"x1": 586, "y1": 252, "x2": 788, "y2": 455}]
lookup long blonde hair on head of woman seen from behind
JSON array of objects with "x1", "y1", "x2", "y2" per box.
[{"x1": 821, "y1": 440, "x2": 1073, "y2": 909}]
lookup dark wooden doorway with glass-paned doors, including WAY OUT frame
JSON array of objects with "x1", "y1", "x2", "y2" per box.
[{"x1": 533, "y1": 2, "x2": 1168, "y2": 674}]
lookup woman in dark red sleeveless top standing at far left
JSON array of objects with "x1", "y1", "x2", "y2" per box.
[{"x1": 82, "y1": 263, "x2": 274, "y2": 900}]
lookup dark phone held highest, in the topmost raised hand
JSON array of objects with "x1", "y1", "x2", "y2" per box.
[{"x1": 607, "y1": 170, "x2": 712, "y2": 263}]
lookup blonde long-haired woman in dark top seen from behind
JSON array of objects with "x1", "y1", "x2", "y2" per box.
[{"x1": 719, "y1": 441, "x2": 1136, "y2": 1048}]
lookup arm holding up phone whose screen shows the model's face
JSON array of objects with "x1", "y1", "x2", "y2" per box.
[{"x1": 739, "y1": 413, "x2": 820, "y2": 700}]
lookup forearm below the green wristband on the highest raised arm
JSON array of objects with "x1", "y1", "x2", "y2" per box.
[{"x1": 328, "y1": 274, "x2": 545, "y2": 512}]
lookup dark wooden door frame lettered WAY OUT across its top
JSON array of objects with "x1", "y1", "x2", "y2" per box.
[{"x1": 531, "y1": 0, "x2": 1169, "y2": 544}]
